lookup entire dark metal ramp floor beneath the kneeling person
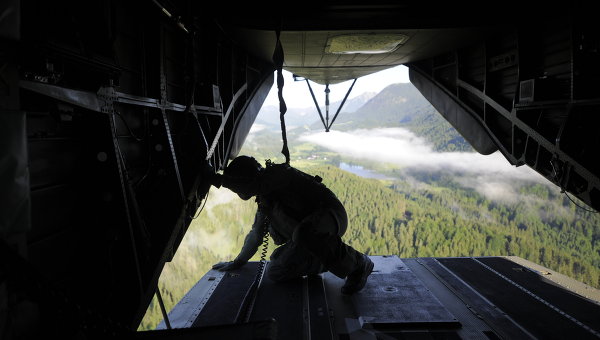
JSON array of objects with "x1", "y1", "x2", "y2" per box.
[{"x1": 163, "y1": 255, "x2": 600, "y2": 340}]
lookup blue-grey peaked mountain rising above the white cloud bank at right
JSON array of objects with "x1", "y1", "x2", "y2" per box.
[{"x1": 310, "y1": 83, "x2": 473, "y2": 151}]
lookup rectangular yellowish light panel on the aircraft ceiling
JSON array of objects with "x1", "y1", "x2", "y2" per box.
[{"x1": 325, "y1": 33, "x2": 408, "y2": 54}]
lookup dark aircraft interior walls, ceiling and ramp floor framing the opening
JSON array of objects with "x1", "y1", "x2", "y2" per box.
[{"x1": 0, "y1": 0, "x2": 600, "y2": 339}]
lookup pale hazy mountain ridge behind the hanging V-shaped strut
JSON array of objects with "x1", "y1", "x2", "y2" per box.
[{"x1": 256, "y1": 92, "x2": 377, "y2": 130}]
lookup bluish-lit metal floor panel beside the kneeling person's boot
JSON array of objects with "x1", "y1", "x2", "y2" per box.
[{"x1": 324, "y1": 256, "x2": 461, "y2": 340}]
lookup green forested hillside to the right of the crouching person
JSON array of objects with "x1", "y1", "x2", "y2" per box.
[{"x1": 306, "y1": 162, "x2": 600, "y2": 288}]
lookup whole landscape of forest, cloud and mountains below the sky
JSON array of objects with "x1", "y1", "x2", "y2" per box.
[{"x1": 140, "y1": 79, "x2": 600, "y2": 329}]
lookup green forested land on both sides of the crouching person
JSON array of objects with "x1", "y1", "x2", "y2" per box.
[{"x1": 141, "y1": 158, "x2": 600, "y2": 329}]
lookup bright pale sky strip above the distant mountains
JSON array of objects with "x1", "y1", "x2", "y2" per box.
[{"x1": 264, "y1": 65, "x2": 409, "y2": 108}]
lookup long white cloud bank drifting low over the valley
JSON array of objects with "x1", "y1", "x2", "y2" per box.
[{"x1": 300, "y1": 128, "x2": 549, "y2": 201}]
